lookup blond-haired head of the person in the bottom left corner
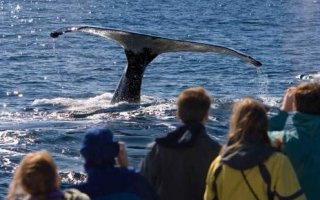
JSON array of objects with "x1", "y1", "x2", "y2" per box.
[{"x1": 9, "y1": 151, "x2": 60, "y2": 200}]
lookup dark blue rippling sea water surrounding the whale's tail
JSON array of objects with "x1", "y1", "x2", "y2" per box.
[{"x1": 0, "y1": 0, "x2": 320, "y2": 199}]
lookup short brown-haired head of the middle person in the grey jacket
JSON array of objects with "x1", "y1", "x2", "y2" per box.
[{"x1": 177, "y1": 87, "x2": 211, "y2": 124}]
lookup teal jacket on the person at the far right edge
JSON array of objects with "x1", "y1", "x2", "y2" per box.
[{"x1": 269, "y1": 111, "x2": 320, "y2": 200}]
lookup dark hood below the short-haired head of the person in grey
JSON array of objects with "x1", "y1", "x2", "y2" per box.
[{"x1": 156, "y1": 123, "x2": 206, "y2": 148}]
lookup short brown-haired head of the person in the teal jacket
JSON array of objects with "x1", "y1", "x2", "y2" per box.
[{"x1": 295, "y1": 83, "x2": 320, "y2": 115}]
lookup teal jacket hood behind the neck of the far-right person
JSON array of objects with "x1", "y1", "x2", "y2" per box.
[{"x1": 292, "y1": 112, "x2": 320, "y2": 140}]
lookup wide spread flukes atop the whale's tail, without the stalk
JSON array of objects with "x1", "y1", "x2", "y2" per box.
[{"x1": 50, "y1": 26, "x2": 262, "y2": 67}]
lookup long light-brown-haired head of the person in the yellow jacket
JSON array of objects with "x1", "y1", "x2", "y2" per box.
[{"x1": 229, "y1": 97, "x2": 270, "y2": 146}]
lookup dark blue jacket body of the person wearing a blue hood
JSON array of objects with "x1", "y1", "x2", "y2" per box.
[{"x1": 72, "y1": 166, "x2": 158, "y2": 200}]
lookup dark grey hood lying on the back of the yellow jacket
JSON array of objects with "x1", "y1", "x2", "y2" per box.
[{"x1": 221, "y1": 144, "x2": 276, "y2": 170}]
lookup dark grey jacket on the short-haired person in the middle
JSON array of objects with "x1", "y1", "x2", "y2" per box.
[{"x1": 141, "y1": 125, "x2": 221, "y2": 200}]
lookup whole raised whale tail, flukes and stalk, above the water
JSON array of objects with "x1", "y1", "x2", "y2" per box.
[{"x1": 50, "y1": 26, "x2": 262, "y2": 103}]
